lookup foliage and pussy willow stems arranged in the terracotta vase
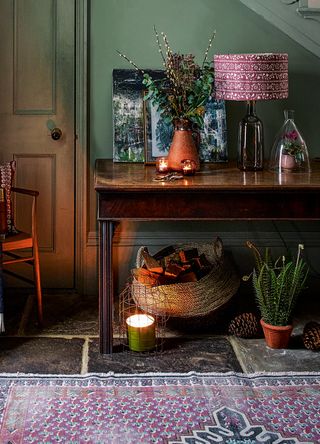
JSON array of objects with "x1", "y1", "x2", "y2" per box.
[{"x1": 118, "y1": 27, "x2": 215, "y2": 128}]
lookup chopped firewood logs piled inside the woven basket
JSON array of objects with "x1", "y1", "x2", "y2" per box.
[{"x1": 133, "y1": 246, "x2": 212, "y2": 287}]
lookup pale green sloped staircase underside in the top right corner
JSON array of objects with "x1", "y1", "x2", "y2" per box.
[{"x1": 240, "y1": 0, "x2": 320, "y2": 57}]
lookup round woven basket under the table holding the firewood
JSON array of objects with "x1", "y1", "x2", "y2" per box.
[{"x1": 131, "y1": 240, "x2": 240, "y2": 318}]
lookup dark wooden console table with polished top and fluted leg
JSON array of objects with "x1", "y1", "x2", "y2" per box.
[{"x1": 95, "y1": 159, "x2": 320, "y2": 354}]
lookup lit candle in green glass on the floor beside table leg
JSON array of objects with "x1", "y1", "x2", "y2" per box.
[{"x1": 126, "y1": 314, "x2": 156, "y2": 352}]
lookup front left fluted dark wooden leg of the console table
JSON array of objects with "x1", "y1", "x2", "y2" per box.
[{"x1": 99, "y1": 221, "x2": 113, "y2": 354}]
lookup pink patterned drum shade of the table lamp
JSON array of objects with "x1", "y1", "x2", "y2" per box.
[{"x1": 214, "y1": 53, "x2": 288, "y2": 100}]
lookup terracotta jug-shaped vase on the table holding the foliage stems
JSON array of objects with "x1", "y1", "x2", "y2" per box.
[{"x1": 168, "y1": 119, "x2": 200, "y2": 171}]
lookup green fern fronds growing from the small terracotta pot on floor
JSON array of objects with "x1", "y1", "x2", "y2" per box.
[{"x1": 243, "y1": 241, "x2": 309, "y2": 326}]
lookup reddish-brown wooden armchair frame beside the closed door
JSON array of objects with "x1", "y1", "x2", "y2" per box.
[{"x1": 0, "y1": 187, "x2": 43, "y2": 325}]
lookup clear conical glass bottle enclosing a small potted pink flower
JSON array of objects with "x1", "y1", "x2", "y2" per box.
[{"x1": 269, "y1": 110, "x2": 310, "y2": 173}]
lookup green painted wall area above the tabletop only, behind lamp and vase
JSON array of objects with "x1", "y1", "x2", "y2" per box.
[{"x1": 91, "y1": 0, "x2": 320, "y2": 165}]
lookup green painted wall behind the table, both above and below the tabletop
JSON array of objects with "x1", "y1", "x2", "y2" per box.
[{"x1": 90, "y1": 0, "x2": 320, "y2": 294}]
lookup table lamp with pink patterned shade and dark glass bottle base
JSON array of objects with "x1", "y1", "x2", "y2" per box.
[{"x1": 214, "y1": 53, "x2": 288, "y2": 171}]
